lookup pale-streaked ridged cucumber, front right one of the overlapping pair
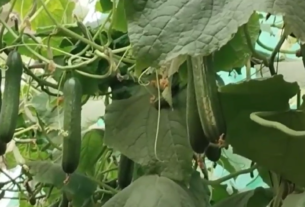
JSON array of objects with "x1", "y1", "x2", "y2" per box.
[{"x1": 191, "y1": 55, "x2": 226, "y2": 143}]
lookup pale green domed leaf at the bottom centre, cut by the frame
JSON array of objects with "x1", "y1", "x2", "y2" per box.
[{"x1": 103, "y1": 175, "x2": 210, "y2": 207}]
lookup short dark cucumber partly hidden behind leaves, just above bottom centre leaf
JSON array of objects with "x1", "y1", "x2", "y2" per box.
[{"x1": 118, "y1": 154, "x2": 134, "y2": 189}]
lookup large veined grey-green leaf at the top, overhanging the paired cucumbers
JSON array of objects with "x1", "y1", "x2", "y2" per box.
[{"x1": 125, "y1": 0, "x2": 305, "y2": 69}]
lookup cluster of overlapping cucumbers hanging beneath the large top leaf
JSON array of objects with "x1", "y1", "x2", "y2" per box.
[{"x1": 186, "y1": 56, "x2": 226, "y2": 162}]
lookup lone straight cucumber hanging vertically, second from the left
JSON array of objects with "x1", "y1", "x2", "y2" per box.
[{"x1": 62, "y1": 77, "x2": 82, "y2": 174}]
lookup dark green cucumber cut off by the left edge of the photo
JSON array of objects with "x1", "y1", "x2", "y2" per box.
[{"x1": 0, "y1": 50, "x2": 23, "y2": 143}]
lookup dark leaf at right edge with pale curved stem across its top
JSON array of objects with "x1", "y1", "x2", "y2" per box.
[{"x1": 227, "y1": 110, "x2": 305, "y2": 186}]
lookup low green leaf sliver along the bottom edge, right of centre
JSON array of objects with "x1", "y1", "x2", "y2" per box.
[{"x1": 213, "y1": 188, "x2": 273, "y2": 207}]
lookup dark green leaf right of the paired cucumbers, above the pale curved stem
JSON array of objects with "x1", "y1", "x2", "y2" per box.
[{"x1": 220, "y1": 75, "x2": 299, "y2": 123}]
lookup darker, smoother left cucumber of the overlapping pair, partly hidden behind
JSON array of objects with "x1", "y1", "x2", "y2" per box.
[{"x1": 186, "y1": 57, "x2": 209, "y2": 154}]
